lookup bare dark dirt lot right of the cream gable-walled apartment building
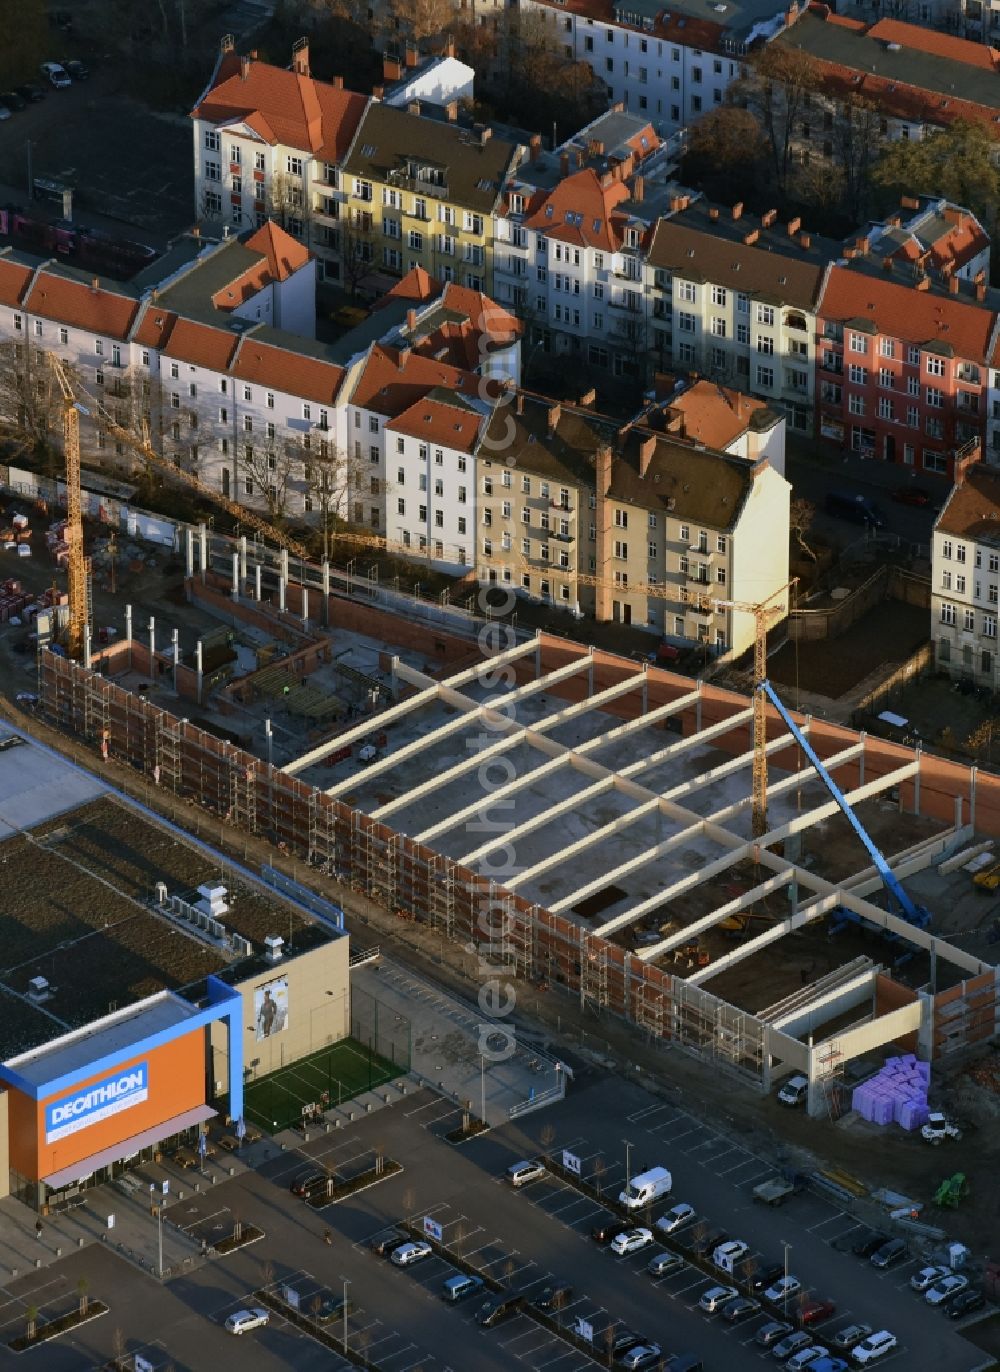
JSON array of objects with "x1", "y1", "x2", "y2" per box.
[{"x1": 768, "y1": 600, "x2": 930, "y2": 700}]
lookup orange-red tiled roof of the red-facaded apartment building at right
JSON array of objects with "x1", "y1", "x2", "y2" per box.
[{"x1": 816, "y1": 266, "x2": 995, "y2": 362}]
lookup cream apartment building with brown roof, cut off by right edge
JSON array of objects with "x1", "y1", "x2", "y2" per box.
[{"x1": 930, "y1": 457, "x2": 1000, "y2": 690}]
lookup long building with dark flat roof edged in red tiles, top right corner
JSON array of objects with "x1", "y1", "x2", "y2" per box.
[{"x1": 775, "y1": 3, "x2": 1000, "y2": 150}]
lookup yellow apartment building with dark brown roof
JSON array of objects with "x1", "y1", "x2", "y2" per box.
[{"x1": 340, "y1": 102, "x2": 524, "y2": 295}]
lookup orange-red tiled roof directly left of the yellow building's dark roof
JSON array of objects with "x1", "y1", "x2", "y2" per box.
[{"x1": 192, "y1": 54, "x2": 368, "y2": 162}]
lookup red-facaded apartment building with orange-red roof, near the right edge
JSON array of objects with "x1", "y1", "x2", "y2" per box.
[{"x1": 818, "y1": 257, "x2": 997, "y2": 475}]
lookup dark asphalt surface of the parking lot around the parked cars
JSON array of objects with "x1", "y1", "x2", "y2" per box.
[{"x1": 11, "y1": 1076, "x2": 982, "y2": 1372}]
